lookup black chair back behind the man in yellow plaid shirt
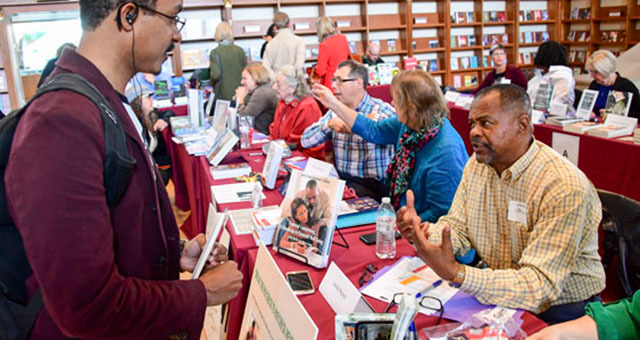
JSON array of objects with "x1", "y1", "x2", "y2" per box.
[{"x1": 598, "y1": 190, "x2": 640, "y2": 297}]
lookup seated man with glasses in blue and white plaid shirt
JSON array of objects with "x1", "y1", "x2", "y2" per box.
[{"x1": 300, "y1": 60, "x2": 396, "y2": 202}]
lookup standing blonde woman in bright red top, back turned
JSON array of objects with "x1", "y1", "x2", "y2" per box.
[{"x1": 312, "y1": 17, "x2": 349, "y2": 88}]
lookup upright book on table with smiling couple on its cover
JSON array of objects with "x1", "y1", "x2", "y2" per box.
[{"x1": 273, "y1": 170, "x2": 345, "y2": 268}]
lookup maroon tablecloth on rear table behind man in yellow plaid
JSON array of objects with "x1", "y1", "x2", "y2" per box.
[{"x1": 449, "y1": 104, "x2": 640, "y2": 201}]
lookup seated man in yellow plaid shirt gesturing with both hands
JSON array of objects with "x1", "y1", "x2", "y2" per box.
[{"x1": 398, "y1": 84, "x2": 605, "y2": 323}]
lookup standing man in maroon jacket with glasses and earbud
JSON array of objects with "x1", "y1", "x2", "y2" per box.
[{"x1": 5, "y1": 0, "x2": 242, "y2": 339}]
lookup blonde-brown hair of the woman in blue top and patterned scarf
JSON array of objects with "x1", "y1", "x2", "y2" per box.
[{"x1": 391, "y1": 70, "x2": 449, "y2": 129}]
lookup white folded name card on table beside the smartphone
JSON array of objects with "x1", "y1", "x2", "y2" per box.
[{"x1": 318, "y1": 262, "x2": 374, "y2": 314}]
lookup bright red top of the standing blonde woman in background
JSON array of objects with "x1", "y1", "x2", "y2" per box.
[{"x1": 316, "y1": 34, "x2": 349, "y2": 88}]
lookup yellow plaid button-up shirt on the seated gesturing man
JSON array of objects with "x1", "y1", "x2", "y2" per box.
[{"x1": 430, "y1": 141, "x2": 605, "y2": 313}]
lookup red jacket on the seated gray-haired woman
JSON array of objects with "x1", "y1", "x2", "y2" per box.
[{"x1": 269, "y1": 96, "x2": 325, "y2": 161}]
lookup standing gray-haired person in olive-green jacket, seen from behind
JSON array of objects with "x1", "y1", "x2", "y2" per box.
[{"x1": 209, "y1": 21, "x2": 247, "y2": 100}]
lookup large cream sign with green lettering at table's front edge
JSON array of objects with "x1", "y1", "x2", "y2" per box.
[{"x1": 239, "y1": 243, "x2": 318, "y2": 340}]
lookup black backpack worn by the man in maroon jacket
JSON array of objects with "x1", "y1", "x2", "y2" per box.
[{"x1": 0, "y1": 73, "x2": 136, "y2": 340}]
